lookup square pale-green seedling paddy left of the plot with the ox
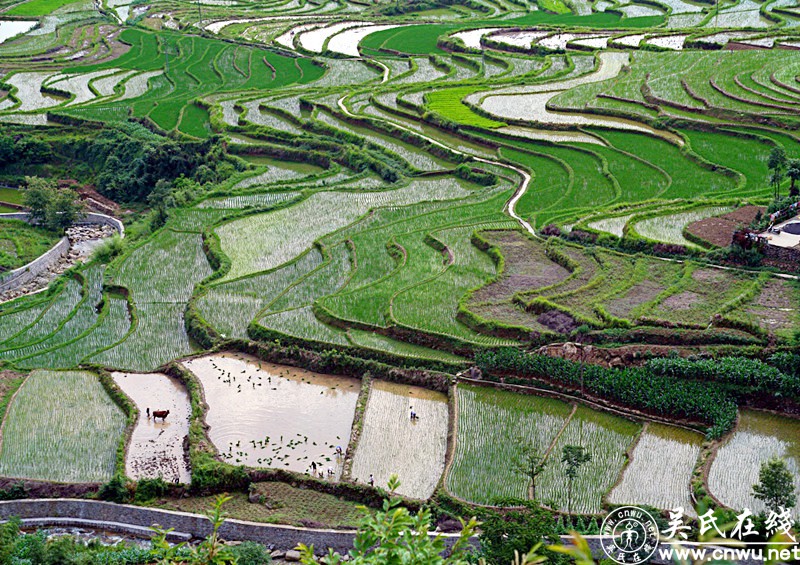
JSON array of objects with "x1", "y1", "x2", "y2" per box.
[{"x1": 0, "y1": 371, "x2": 125, "y2": 483}]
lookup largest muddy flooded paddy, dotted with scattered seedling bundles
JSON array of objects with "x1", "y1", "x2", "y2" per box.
[{"x1": 184, "y1": 353, "x2": 361, "y2": 479}]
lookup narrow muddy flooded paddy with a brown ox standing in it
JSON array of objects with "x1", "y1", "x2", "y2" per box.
[{"x1": 112, "y1": 373, "x2": 191, "y2": 484}]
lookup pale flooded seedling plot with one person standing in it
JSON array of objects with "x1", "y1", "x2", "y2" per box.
[{"x1": 351, "y1": 381, "x2": 448, "y2": 500}]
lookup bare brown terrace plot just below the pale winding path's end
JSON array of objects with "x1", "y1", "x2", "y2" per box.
[{"x1": 472, "y1": 231, "x2": 569, "y2": 303}]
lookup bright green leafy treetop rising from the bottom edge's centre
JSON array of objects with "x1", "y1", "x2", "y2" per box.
[{"x1": 298, "y1": 476, "x2": 478, "y2": 565}]
